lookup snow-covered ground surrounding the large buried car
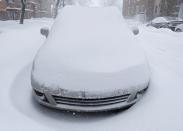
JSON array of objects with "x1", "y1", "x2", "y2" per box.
[{"x1": 0, "y1": 19, "x2": 183, "y2": 131}]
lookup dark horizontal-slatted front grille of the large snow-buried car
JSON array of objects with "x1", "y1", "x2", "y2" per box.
[{"x1": 53, "y1": 94, "x2": 130, "y2": 106}]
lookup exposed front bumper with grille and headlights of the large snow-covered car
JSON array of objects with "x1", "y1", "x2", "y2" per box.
[{"x1": 33, "y1": 88, "x2": 147, "y2": 112}]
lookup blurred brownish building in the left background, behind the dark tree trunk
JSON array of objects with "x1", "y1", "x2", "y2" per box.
[{"x1": 0, "y1": 0, "x2": 54, "y2": 20}]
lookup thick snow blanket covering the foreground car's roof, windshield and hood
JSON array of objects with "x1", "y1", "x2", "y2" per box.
[{"x1": 32, "y1": 6, "x2": 149, "y2": 91}]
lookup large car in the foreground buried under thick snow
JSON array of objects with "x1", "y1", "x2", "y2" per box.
[{"x1": 31, "y1": 6, "x2": 150, "y2": 112}]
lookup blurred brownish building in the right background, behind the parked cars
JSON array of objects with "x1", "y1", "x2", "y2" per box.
[{"x1": 123, "y1": 0, "x2": 183, "y2": 21}]
